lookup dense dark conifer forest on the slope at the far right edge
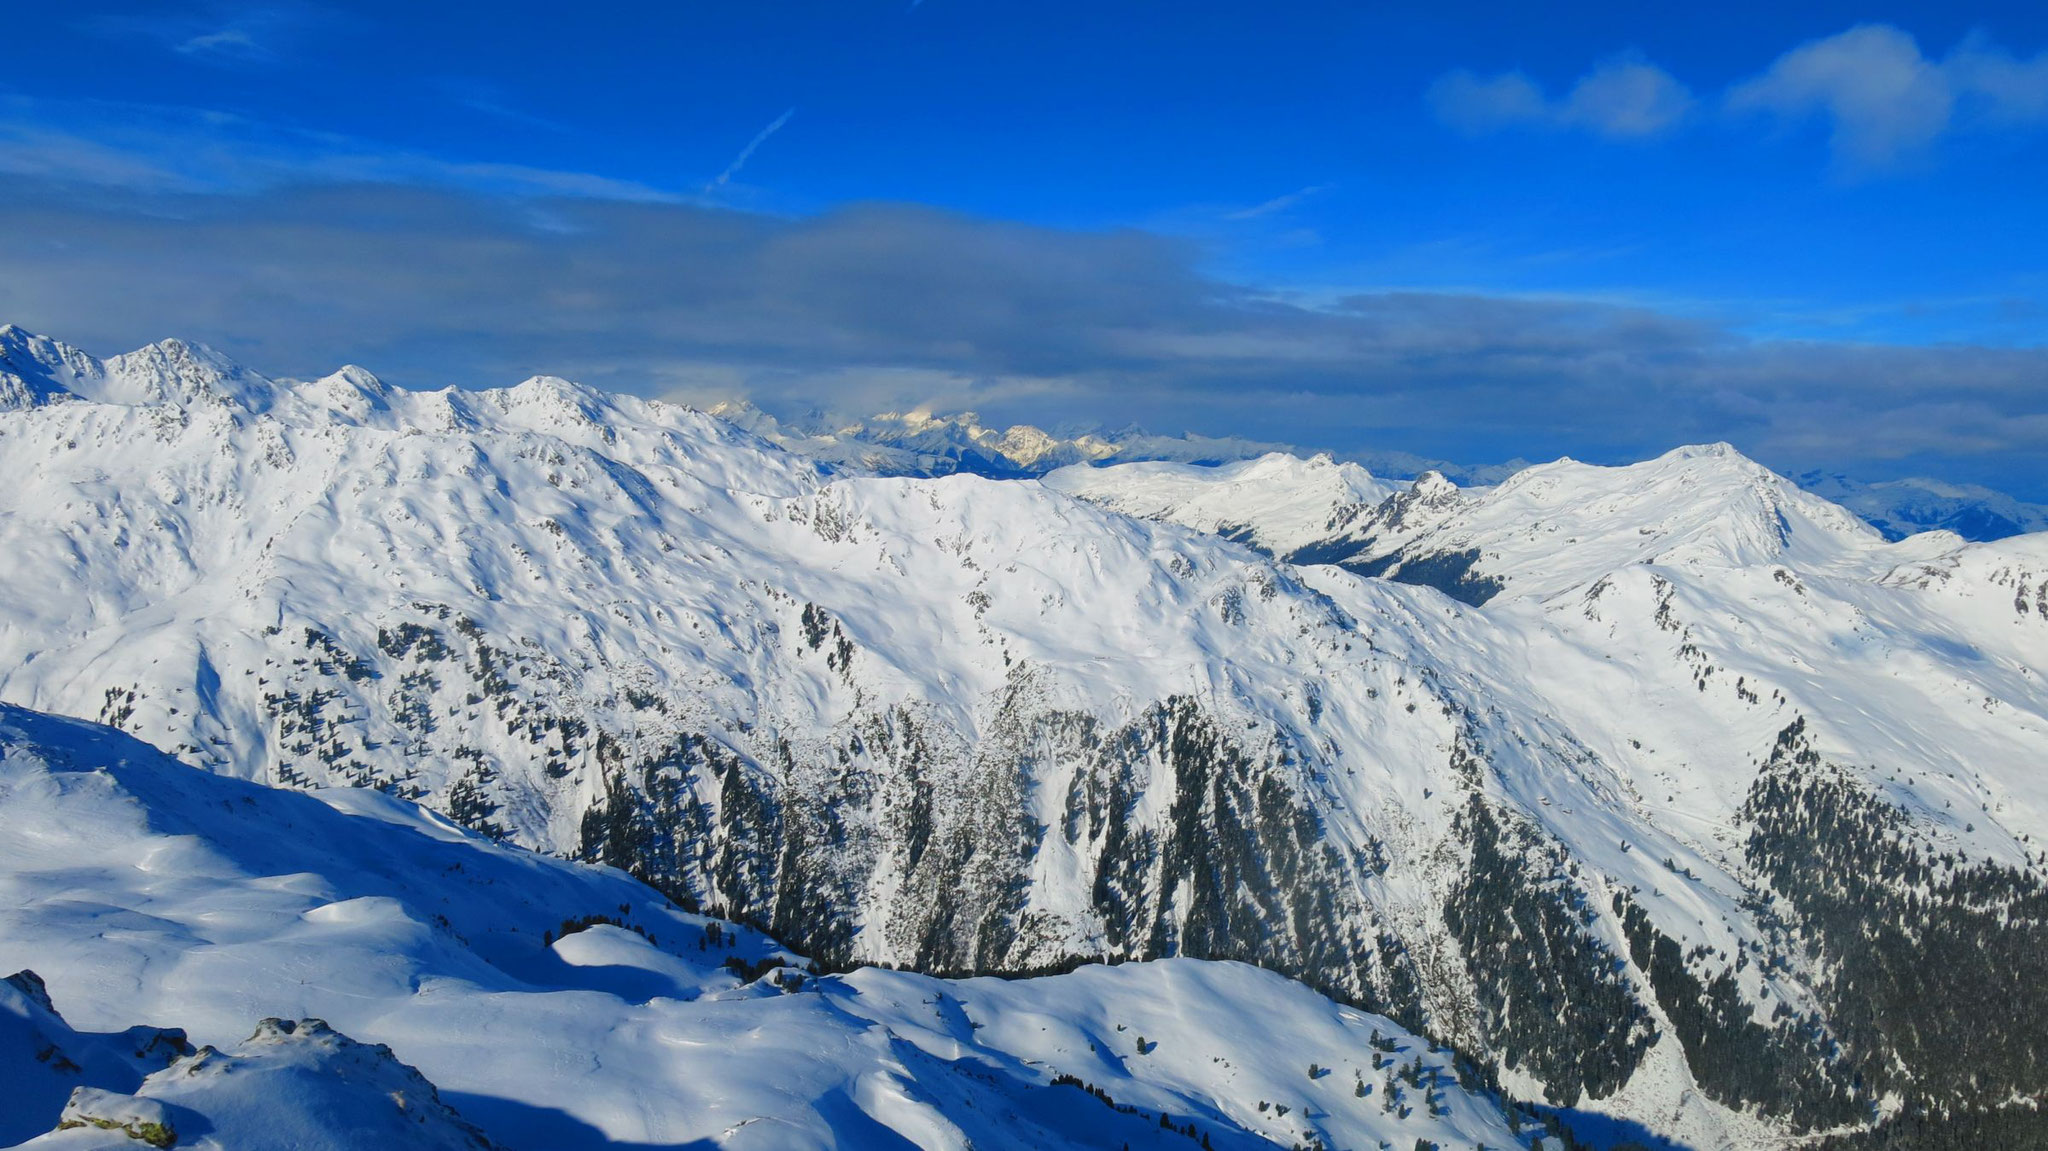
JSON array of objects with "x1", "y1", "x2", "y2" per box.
[{"x1": 1743, "y1": 719, "x2": 2048, "y2": 1122}]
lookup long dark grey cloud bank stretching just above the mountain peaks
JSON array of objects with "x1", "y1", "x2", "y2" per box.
[{"x1": 0, "y1": 180, "x2": 2048, "y2": 498}]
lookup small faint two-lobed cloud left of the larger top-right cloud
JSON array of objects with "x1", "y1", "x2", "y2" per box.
[{"x1": 1430, "y1": 57, "x2": 1694, "y2": 139}]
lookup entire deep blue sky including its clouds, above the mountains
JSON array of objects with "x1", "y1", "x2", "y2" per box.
[{"x1": 0, "y1": 0, "x2": 2048, "y2": 496}]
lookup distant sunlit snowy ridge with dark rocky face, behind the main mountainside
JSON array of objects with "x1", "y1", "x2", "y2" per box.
[{"x1": 1047, "y1": 444, "x2": 1908, "y2": 604}]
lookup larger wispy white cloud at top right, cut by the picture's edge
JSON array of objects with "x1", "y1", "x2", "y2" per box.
[{"x1": 1726, "y1": 25, "x2": 2048, "y2": 170}]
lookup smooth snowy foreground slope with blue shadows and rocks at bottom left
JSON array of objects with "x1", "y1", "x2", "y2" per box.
[{"x1": 0, "y1": 707, "x2": 1511, "y2": 1151}]
